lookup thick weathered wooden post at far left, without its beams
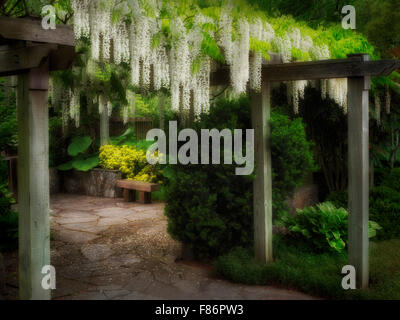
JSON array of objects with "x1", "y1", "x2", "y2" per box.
[{"x1": 17, "y1": 63, "x2": 51, "y2": 300}]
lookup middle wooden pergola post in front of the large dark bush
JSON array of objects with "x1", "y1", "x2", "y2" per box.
[{"x1": 251, "y1": 77, "x2": 273, "y2": 263}]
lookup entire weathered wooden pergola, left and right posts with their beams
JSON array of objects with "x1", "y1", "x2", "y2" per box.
[{"x1": 0, "y1": 17, "x2": 400, "y2": 299}]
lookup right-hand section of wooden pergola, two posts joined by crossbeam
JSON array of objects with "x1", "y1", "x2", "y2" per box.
[{"x1": 211, "y1": 54, "x2": 400, "y2": 288}]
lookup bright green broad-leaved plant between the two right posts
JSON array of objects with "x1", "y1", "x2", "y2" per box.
[{"x1": 282, "y1": 202, "x2": 380, "y2": 252}]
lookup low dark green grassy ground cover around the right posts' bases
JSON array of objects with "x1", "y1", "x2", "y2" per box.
[{"x1": 214, "y1": 236, "x2": 400, "y2": 300}]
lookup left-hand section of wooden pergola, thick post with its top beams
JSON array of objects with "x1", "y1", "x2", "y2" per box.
[{"x1": 0, "y1": 17, "x2": 75, "y2": 300}]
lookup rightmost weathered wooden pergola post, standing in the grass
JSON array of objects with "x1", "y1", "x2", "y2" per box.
[{"x1": 348, "y1": 55, "x2": 370, "y2": 288}]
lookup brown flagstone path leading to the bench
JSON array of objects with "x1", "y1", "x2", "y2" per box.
[{"x1": 2, "y1": 194, "x2": 313, "y2": 300}]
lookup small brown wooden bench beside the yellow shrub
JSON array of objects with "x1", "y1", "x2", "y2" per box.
[{"x1": 116, "y1": 179, "x2": 160, "y2": 203}]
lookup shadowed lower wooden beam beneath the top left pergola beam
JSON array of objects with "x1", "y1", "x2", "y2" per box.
[{"x1": 0, "y1": 44, "x2": 57, "y2": 77}]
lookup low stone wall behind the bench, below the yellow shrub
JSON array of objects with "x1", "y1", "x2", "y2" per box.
[{"x1": 62, "y1": 169, "x2": 122, "y2": 198}]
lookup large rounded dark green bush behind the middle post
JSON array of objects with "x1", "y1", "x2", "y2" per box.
[{"x1": 164, "y1": 98, "x2": 313, "y2": 258}]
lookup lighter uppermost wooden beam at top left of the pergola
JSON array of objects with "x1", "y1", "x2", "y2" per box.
[{"x1": 0, "y1": 17, "x2": 75, "y2": 47}]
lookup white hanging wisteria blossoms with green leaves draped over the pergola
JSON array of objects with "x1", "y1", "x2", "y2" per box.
[{"x1": 71, "y1": 0, "x2": 368, "y2": 122}]
